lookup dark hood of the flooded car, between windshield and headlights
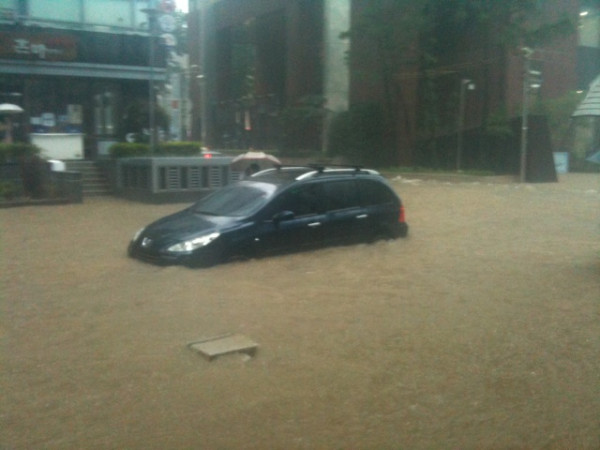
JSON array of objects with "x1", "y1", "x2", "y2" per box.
[{"x1": 142, "y1": 209, "x2": 237, "y2": 243}]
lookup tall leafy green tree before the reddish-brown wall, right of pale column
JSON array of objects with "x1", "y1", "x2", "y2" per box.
[{"x1": 342, "y1": 0, "x2": 573, "y2": 169}]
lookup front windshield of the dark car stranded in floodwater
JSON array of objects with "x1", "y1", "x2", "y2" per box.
[{"x1": 191, "y1": 183, "x2": 275, "y2": 217}]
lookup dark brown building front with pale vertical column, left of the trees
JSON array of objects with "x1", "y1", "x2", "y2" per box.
[{"x1": 189, "y1": 0, "x2": 351, "y2": 148}]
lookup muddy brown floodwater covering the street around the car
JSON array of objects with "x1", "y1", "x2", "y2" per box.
[{"x1": 0, "y1": 174, "x2": 600, "y2": 449}]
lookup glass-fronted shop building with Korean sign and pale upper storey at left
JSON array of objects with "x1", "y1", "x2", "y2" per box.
[{"x1": 0, "y1": 0, "x2": 173, "y2": 159}]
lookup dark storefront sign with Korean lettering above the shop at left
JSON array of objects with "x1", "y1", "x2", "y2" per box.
[{"x1": 0, "y1": 32, "x2": 77, "y2": 61}]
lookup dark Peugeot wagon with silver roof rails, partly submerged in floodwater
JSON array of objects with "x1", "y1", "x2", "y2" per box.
[{"x1": 129, "y1": 166, "x2": 408, "y2": 266}]
